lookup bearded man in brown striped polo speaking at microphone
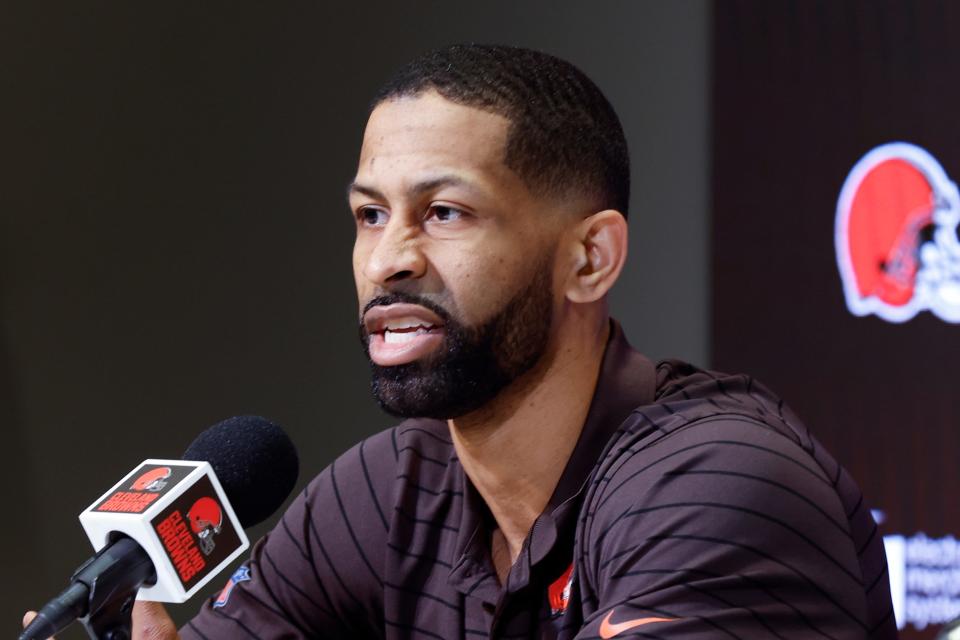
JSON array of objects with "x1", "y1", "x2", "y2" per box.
[{"x1": 22, "y1": 46, "x2": 896, "y2": 640}]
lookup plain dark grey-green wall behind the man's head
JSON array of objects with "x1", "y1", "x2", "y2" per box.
[{"x1": 0, "y1": 0, "x2": 711, "y2": 638}]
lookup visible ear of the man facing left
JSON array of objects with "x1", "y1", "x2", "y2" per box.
[{"x1": 566, "y1": 209, "x2": 627, "y2": 303}]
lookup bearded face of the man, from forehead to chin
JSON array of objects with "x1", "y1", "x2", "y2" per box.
[{"x1": 350, "y1": 92, "x2": 560, "y2": 418}]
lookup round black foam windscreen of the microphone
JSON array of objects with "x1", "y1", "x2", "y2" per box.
[{"x1": 183, "y1": 416, "x2": 300, "y2": 529}]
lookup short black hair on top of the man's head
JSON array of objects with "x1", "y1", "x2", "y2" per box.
[{"x1": 372, "y1": 44, "x2": 630, "y2": 217}]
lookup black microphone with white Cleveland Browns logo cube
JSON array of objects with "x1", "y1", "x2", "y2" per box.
[{"x1": 19, "y1": 416, "x2": 299, "y2": 640}]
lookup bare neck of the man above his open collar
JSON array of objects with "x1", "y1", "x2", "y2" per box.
[{"x1": 449, "y1": 312, "x2": 610, "y2": 580}]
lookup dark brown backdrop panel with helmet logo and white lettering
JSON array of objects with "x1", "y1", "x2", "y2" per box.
[{"x1": 711, "y1": 1, "x2": 960, "y2": 638}]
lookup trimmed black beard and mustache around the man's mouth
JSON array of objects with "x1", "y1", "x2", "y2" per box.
[{"x1": 360, "y1": 261, "x2": 553, "y2": 420}]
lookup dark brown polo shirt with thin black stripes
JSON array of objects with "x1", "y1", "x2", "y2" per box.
[{"x1": 181, "y1": 323, "x2": 896, "y2": 640}]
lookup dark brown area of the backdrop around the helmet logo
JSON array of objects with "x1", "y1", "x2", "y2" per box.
[{"x1": 711, "y1": 1, "x2": 960, "y2": 638}]
